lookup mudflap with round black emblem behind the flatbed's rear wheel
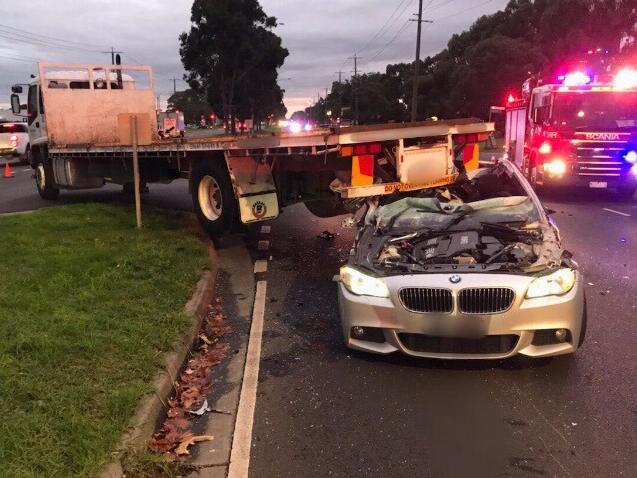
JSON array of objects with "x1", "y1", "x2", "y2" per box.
[{"x1": 225, "y1": 153, "x2": 279, "y2": 224}]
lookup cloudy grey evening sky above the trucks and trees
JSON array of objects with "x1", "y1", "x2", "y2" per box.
[{"x1": 0, "y1": 0, "x2": 508, "y2": 113}]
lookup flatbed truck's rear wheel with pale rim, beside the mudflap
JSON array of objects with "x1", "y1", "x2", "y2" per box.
[{"x1": 192, "y1": 161, "x2": 237, "y2": 237}]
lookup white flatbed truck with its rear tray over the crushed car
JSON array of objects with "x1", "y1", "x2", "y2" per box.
[{"x1": 11, "y1": 62, "x2": 493, "y2": 236}]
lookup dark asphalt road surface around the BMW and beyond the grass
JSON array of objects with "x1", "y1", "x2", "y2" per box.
[{"x1": 0, "y1": 167, "x2": 637, "y2": 478}]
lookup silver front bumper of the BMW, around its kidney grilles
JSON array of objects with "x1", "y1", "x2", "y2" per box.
[{"x1": 338, "y1": 273, "x2": 586, "y2": 359}]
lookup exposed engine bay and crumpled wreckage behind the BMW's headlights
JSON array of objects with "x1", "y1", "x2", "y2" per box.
[{"x1": 351, "y1": 165, "x2": 562, "y2": 275}]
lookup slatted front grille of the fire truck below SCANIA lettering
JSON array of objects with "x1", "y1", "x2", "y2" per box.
[{"x1": 574, "y1": 140, "x2": 628, "y2": 177}]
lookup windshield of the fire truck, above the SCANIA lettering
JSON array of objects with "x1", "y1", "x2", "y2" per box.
[{"x1": 553, "y1": 92, "x2": 637, "y2": 130}]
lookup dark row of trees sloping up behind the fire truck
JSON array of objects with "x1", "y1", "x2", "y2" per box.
[{"x1": 308, "y1": 0, "x2": 637, "y2": 123}]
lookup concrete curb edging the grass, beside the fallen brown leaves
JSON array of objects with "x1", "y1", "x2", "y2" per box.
[{"x1": 99, "y1": 241, "x2": 218, "y2": 478}]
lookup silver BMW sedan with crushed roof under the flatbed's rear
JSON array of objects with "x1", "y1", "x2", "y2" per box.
[{"x1": 338, "y1": 161, "x2": 586, "y2": 359}]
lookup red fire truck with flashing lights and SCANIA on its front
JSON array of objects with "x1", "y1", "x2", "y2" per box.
[{"x1": 505, "y1": 68, "x2": 637, "y2": 200}]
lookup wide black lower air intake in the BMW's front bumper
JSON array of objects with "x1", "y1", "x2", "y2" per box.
[{"x1": 398, "y1": 333, "x2": 519, "y2": 355}]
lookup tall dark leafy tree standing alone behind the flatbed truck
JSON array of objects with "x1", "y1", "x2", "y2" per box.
[{"x1": 179, "y1": 0, "x2": 289, "y2": 129}]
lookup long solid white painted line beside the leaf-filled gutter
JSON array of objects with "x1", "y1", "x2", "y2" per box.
[{"x1": 228, "y1": 281, "x2": 268, "y2": 478}]
